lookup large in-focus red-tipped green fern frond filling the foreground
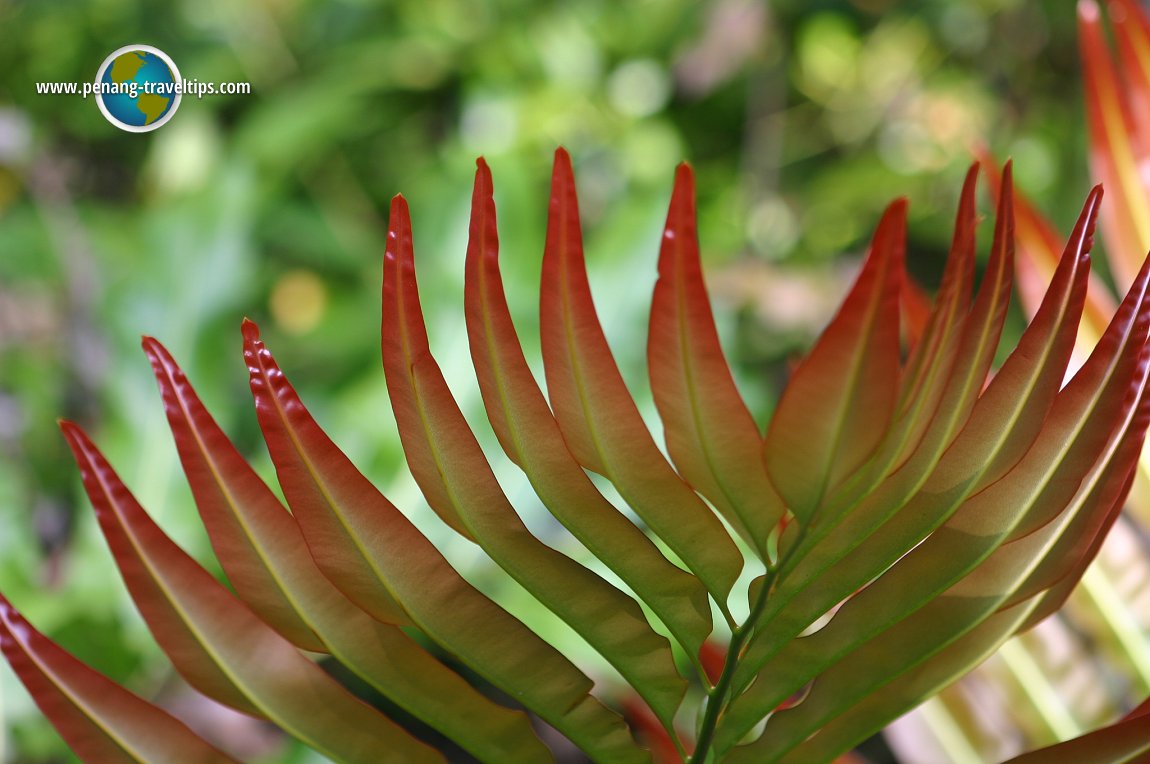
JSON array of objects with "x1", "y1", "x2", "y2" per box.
[{"x1": 0, "y1": 150, "x2": 1150, "y2": 763}]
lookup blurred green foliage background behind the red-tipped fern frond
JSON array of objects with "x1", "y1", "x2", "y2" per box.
[{"x1": 0, "y1": 0, "x2": 1101, "y2": 764}]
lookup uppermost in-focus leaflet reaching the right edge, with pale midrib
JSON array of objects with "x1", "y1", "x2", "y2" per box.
[{"x1": 717, "y1": 202, "x2": 1150, "y2": 759}]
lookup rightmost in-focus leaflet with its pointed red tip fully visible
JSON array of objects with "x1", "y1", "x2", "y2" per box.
[{"x1": 723, "y1": 189, "x2": 1101, "y2": 743}]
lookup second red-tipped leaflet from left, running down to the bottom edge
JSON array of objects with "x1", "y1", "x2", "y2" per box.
[{"x1": 61, "y1": 422, "x2": 443, "y2": 764}]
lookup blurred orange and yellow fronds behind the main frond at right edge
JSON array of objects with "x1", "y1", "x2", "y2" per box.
[{"x1": 895, "y1": 0, "x2": 1150, "y2": 762}]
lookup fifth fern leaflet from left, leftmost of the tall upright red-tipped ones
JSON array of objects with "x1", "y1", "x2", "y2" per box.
[{"x1": 383, "y1": 170, "x2": 687, "y2": 732}]
